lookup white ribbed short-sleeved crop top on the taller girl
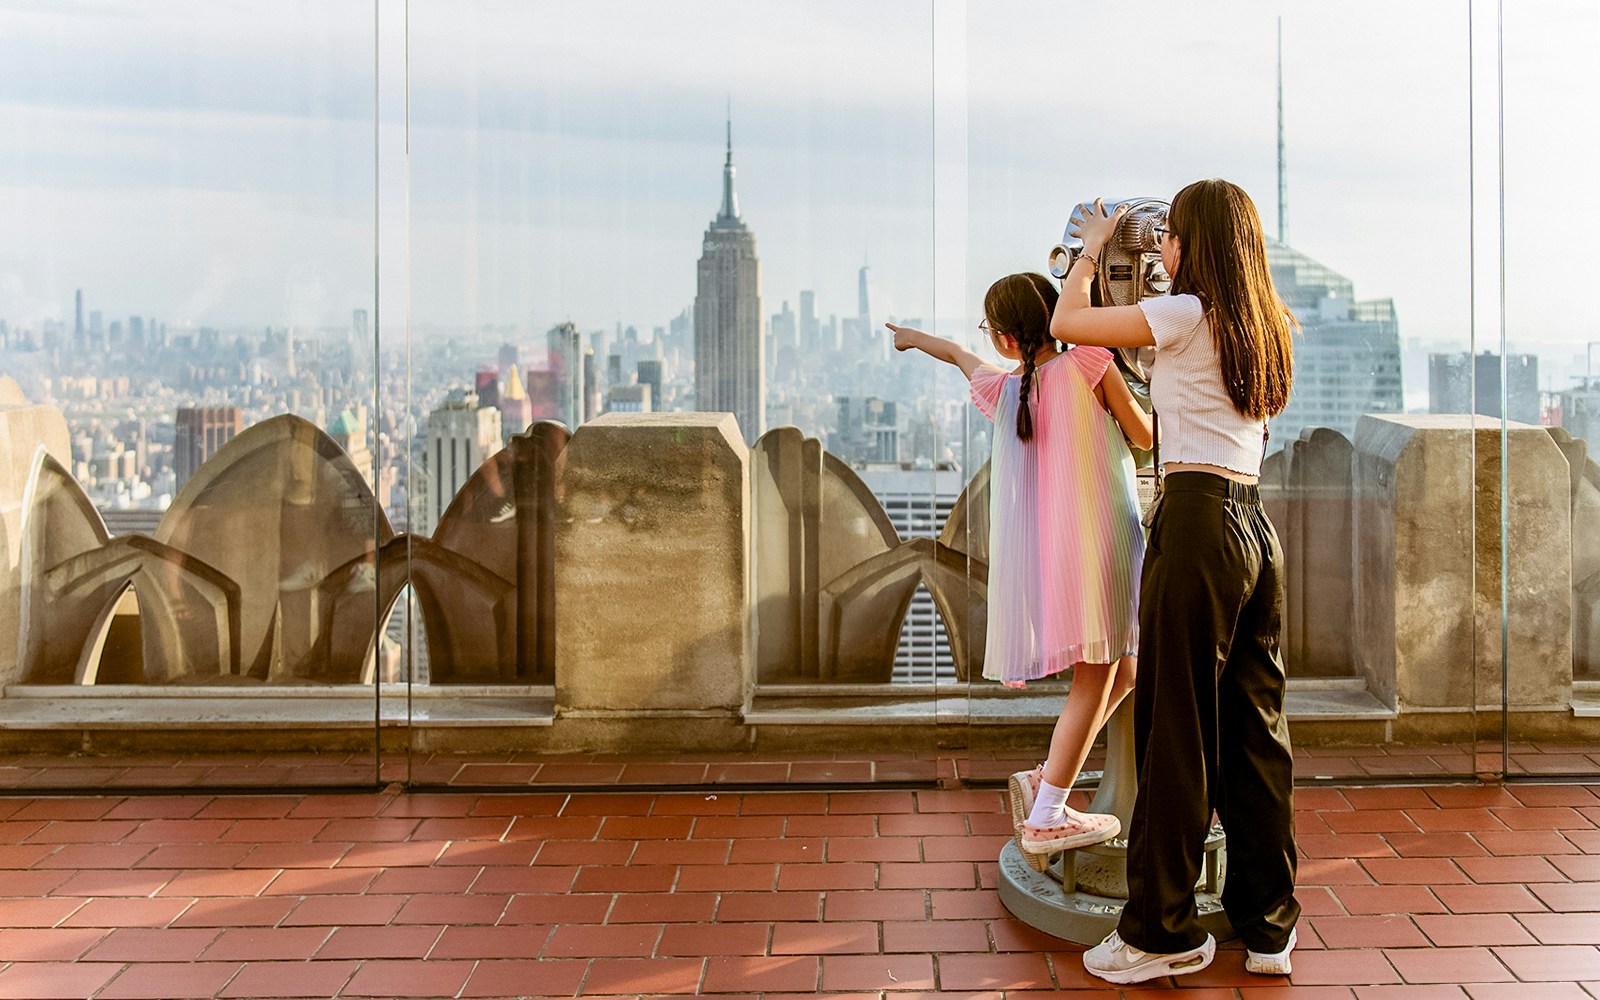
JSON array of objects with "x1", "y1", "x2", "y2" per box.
[{"x1": 1139, "y1": 294, "x2": 1266, "y2": 475}]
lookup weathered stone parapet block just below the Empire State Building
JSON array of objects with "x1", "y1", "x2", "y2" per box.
[{"x1": 555, "y1": 413, "x2": 754, "y2": 717}]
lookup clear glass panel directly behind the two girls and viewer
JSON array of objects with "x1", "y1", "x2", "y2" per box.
[{"x1": 962, "y1": 2, "x2": 1478, "y2": 781}]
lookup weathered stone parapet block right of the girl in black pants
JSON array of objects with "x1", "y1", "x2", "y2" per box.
[{"x1": 1355, "y1": 414, "x2": 1573, "y2": 712}]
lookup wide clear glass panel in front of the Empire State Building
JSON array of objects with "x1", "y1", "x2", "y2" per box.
[{"x1": 406, "y1": 0, "x2": 940, "y2": 784}]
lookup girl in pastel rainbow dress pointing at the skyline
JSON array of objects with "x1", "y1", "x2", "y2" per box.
[{"x1": 888, "y1": 274, "x2": 1150, "y2": 870}]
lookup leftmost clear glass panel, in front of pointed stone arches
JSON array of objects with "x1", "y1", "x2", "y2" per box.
[{"x1": 0, "y1": 3, "x2": 380, "y2": 789}]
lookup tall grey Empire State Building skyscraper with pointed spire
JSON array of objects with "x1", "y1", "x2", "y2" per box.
[{"x1": 694, "y1": 120, "x2": 766, "y2": 443}]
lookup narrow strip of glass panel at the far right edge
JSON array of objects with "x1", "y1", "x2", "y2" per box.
[{"x1": 1491, "y1": 0, "x2": 1600, "y2": 778}]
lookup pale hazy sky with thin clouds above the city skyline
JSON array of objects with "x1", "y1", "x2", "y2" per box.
[{"x1": 0, "y1": 0, "x2": 1600, "y2": 358}]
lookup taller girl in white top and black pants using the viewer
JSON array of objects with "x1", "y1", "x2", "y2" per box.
[{"x1": 1051, "y1": 181, "x2": 1299, "y2": 984}]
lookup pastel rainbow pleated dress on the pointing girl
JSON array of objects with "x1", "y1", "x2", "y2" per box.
[{"x1": 971, "y1": 347, "x2": 1144, "y2": 682}]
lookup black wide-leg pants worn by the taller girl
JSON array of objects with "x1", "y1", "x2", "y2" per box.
[{"x1": 1117, "y1": 472, "x2": 1299, "y2": 954}]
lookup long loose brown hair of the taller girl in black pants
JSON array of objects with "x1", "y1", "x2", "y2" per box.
[{"x1": 1166, "y1": 179, "x2": 1299, "y2": 419}]
